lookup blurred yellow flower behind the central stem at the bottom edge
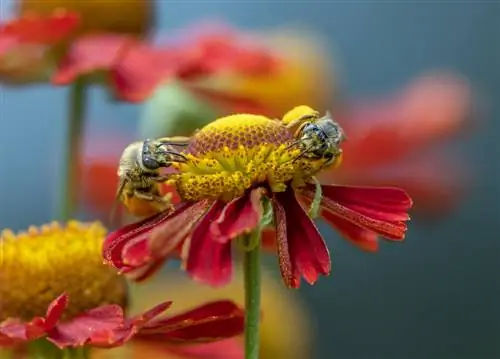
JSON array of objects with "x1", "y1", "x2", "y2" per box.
[{"x1": 92, "y1": 268, "x2": 313, "y2": 359}]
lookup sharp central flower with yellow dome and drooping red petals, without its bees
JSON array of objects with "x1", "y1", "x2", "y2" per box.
[{"x1": 103, "y1": 106, "x2": 412, "y2": 288}]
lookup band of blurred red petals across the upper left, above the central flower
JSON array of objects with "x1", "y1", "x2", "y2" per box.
[{"x1": 52, "y1": 24, "x2": 282, "y2": 102}]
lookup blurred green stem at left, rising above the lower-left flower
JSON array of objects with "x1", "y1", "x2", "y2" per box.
[{"x1": 59, "y1": 78, "x2": 86, "y2": 221}]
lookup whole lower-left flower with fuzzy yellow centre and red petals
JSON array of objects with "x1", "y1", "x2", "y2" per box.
[{"x1": 0, "y1": 222, "x2": 243, "y2": 354}]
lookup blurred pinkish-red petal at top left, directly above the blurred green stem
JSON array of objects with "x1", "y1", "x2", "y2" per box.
[{"x1": 52, "y1": 35, "x2": 133, "y2": 85}]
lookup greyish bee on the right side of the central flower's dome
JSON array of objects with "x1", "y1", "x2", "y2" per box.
[{"x1": 283, "y1": 106, "x2": 346, "y2": 167}]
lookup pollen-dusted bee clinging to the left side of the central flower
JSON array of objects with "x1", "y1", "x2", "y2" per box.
[{"x1": 111, "y1": 137, "x2": 189, "y2": 221}]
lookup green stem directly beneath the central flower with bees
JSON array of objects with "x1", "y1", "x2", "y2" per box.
[{"x1": 243, "y1": 231, "x2": 260, "y2": 359}]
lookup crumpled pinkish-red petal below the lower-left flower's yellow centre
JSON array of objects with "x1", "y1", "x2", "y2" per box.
[{"x1": 47, "y1": 305, "x2": 124, "y2": 349}]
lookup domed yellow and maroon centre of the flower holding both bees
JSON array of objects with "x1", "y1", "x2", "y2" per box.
[{"x1": 167, "y1": 114, "x2": 325, "y2": 201}]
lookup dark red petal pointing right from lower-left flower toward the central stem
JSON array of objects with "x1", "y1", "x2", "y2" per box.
[{"x1": 139, "y1": 300, "x2": 245, "y2": 342}]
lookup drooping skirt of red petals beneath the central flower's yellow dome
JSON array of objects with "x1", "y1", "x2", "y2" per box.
[{"x1": 103, "y1": 186, "x2": 412, "y2": 288}]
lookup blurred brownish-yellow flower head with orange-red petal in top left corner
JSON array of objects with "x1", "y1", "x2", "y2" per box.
[{"x1": 0, "y1": 0, "x2": 153, "y2": 85}]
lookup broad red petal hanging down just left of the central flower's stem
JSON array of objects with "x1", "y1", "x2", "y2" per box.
[{"x1": 186, "y1": 201, "x2": 232, "y2": 286}]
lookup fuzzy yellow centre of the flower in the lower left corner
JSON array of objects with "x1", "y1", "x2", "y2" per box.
[{"x1": 0, "y1": 222, "x2": 126, "y2": 321}]
